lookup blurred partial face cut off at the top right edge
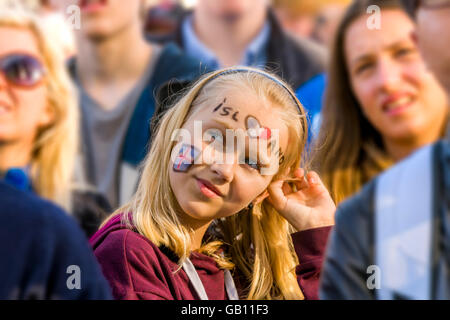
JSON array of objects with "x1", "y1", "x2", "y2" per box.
[{"x1": 416, "y1": 6, "x2": 450, "y2": 96}]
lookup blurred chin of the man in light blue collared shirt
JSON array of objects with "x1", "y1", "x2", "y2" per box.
[{"x1": 197, "y1": 0, "x2": 268, "y2": 22}]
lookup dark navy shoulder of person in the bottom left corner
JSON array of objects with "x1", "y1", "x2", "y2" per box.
[{"x1": 0, "y1": 183, "x2": 110, "y2": 299}]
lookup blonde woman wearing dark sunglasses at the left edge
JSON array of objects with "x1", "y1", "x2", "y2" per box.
[{"x1": 0, "y1": 5, "x2": 109, "y2": 234}]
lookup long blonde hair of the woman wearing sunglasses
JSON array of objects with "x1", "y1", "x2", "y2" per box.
[{"x1": 0, "y1": 3, "x2": 79, "y2": 211}]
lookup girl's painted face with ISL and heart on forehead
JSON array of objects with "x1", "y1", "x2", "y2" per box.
[{"x1": 169, "y1": 89, "x2": 288, "y2": 222}]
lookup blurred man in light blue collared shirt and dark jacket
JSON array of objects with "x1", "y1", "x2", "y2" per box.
[{"x1": 155, "y1": 0, "x2": 326, "y2": 140}]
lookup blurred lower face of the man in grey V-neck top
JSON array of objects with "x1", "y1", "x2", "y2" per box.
[{"x1": 64, "y1": 0, "x2": 144, "y2": 39}]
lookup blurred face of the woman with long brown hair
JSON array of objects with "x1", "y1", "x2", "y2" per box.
[{"x1": 344, "y1": 9, "x2": 448, "y2": 140}]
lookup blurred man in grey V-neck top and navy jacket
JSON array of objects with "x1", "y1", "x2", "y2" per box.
[{"x1": 66, "y1": 0, "x2": 202, "y2": 208}]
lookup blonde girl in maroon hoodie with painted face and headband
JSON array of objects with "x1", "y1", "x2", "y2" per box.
[{"x1": 91, "y1": 68, "x2": 335, "y2": 300}]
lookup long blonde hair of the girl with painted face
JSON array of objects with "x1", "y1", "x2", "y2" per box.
[{"x1": 107, "y1": 68, "x2": 307, "y2": 299}]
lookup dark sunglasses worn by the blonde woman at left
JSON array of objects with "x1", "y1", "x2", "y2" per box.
[{"x1": 0, "y1": 53, "x2": 46, "y2": 88}]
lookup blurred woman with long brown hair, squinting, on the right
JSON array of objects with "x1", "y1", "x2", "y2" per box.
[{"x1": 314, "y1": 0, "x2": 449, "y2": 203}]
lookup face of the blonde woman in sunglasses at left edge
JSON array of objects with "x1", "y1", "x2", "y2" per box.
[{"x1": 0, "y1": 27, "x2": 52, "y2": 146}]
